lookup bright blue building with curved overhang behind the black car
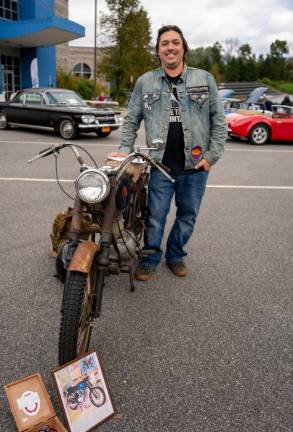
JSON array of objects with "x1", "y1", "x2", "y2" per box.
[{"x1": 0, "y1": 0, "x2": 85, "y2": 98}]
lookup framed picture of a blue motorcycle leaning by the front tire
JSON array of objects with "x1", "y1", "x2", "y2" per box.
[{"x1": 52, "y1": 351, "x2": 115, "y2": 432}]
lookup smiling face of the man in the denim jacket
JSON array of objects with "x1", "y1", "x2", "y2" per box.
[{"x1": 158, "y1": 30, "x2": 184, "y2": 69}]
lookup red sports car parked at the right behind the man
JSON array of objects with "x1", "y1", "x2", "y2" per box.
[{"x1": 226, "y1": 105, "x2": 293, "y2": 145}]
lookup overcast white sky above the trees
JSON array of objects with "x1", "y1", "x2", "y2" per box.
[{"x1": 69, "y1": 0, "x2": 293, "y2": 56}]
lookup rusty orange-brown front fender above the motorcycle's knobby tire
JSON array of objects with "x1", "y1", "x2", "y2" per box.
[{"x1": 68, "y1": 240, "x2": 99, "y2": 273}]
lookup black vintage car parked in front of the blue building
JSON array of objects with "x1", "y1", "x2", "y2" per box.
[{"x1": 0, "y1": 88, "x2": 122, "y2": 140}]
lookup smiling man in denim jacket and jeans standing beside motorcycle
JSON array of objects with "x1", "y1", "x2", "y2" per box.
[{"x1": 120, "y1": 25, "x2": 226, "y2": 281}]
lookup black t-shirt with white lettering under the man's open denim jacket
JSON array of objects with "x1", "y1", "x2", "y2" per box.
[{"x1": 162, "y1": 74, "x2": 185, "y2": 174}]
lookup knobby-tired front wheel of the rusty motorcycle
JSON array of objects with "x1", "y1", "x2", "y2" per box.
[{"x1": 59, "y1": 272, "x2": 96, "y2": 365}]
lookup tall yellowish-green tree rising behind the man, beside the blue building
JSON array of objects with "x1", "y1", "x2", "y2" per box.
[{"x1": 99, "y1": 0, "x2": 153, "y2": 102}]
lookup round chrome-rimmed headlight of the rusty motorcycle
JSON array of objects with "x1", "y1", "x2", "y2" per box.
[{"x1": 75, "y1": 168, "x2": 110, "y2": 204}]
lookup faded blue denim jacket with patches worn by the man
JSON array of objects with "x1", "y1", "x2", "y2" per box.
[{"x1": 119, "y1": 66, "x2": 227, "y2": 169}]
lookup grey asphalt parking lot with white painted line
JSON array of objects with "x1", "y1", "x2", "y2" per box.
[{"x1": 0, "y1": 126, "x2": 293, "y2": 432}]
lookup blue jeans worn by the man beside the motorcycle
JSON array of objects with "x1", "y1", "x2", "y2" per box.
[{"x1": 140, "y1": 170, "x2": 208, "y2": 268}]
